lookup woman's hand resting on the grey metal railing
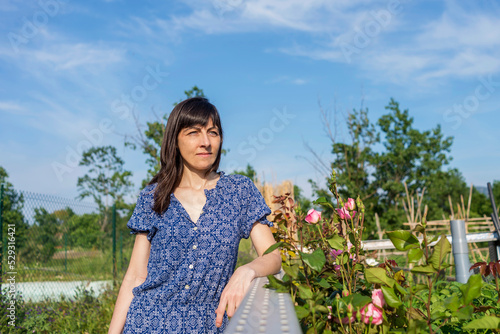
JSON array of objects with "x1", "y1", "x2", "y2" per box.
[{"x1": 215, "y1": 265, "x2": 255, "y2": 327}]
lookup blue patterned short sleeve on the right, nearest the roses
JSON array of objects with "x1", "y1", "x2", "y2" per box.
[{"x1": 240, "y1": 177, "x2": 273, "y2": 239}]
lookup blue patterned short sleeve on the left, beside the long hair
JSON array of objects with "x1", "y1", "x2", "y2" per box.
[{"x1": 127, "y1": 185, "x2": 157, "y2": 242}]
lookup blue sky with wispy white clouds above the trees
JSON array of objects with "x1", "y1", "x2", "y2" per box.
[{"x1": 0, "y1": 0, "x2": 500, "y2": 200}]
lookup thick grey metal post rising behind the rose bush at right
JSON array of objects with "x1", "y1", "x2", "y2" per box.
[{"x1": 450, "y1": 220, "x2": 470, "y2": 283}]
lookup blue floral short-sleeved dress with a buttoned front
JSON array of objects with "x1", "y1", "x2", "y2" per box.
[{"x1": 123, "y1": 172, "x2": 272, "y2": 334}]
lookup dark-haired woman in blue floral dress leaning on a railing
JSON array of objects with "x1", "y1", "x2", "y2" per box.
[{"x1": 108, "y1": 97, "x2": 281, "y2": 334}]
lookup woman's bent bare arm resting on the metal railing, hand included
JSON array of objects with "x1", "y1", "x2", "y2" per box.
[{"x1": 215, "y1": 223, "x2": 281, "y2": 327}]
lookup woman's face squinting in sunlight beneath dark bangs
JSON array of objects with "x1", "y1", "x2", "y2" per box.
[{"x1": 177, "y1": 119, "x2": 221, "y2": 171}]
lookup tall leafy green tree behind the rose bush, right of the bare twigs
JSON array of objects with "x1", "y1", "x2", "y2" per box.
[{"x1": 373, "y1": 99, "x2": 466, "y2": 229}]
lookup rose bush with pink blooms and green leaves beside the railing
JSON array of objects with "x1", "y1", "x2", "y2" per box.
[{"x1": 266, "y1": 173, "x2": 500, "y2": 333}]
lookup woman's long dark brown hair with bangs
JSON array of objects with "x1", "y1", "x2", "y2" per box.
[{"x1": 149, "y1": 97, "x2": 223, "y2": 215}]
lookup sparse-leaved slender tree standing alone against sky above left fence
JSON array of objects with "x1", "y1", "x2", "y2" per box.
[{"x1": 77, "y1": 146, "x2": 132, "y2": 231}]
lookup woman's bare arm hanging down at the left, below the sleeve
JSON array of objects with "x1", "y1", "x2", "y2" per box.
[{"x1": 108, "y1": 233, "x2": 151, "y2": 334}]
